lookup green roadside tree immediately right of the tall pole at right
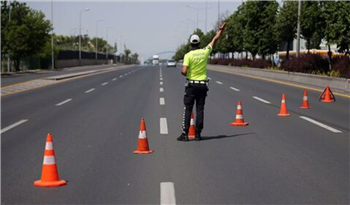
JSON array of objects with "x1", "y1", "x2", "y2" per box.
[{"x1": 300, "y1": 0, "x2": 325, "y2": 50}]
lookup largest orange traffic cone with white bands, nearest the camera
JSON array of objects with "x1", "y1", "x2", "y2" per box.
[{"x1": 34, "y1": 133, "x2": 67, "y2": 187}]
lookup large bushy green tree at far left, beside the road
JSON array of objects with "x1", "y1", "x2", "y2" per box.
[{"x1": 4, "y1": 2, "x2": 52, "y2": 71}]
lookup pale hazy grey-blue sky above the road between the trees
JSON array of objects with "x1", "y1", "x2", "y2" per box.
[{"x1": 19, "y1": 0, "x2": 242, "y2": 60}]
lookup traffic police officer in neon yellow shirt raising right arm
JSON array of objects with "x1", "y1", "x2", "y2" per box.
[{"x1": 177, "y1": 23, "x2": 226, "y2": 141}]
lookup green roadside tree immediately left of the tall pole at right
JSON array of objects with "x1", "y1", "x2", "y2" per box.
[{"x1": 276, "y1": 0, "x2": 298, "y2": 59}]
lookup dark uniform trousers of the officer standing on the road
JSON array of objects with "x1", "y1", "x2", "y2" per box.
[{"x1": 182, "y1": 84, "x2": 208, "y2": 135}]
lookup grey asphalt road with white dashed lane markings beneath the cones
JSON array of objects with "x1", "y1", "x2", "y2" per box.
[{"x1": 0, "y1": 66, "x2": 350, "y2": 204}]
